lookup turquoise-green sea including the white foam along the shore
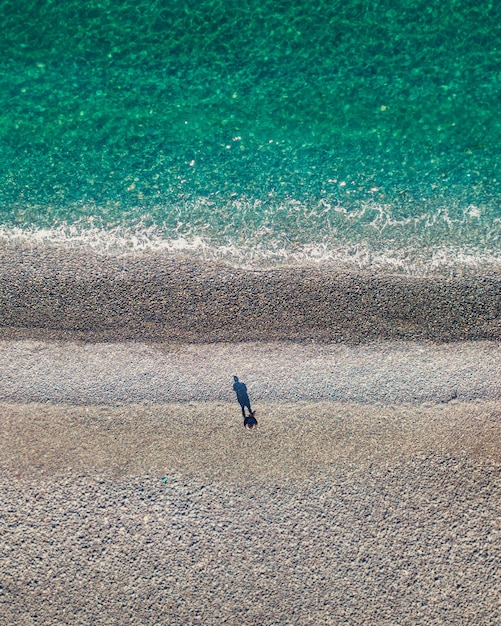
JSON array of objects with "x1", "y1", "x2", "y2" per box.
[{"x1": 0, "y1": 0, "x2": 501, "y2": 271}]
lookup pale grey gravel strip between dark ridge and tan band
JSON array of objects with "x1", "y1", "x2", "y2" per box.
[{"x1": 0, "y1": 340, "x2": 501, "y2": 404}]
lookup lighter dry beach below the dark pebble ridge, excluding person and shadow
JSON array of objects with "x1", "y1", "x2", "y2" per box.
[{"x1": 0, "y1": 340, "x2": 501, "y2": 626}]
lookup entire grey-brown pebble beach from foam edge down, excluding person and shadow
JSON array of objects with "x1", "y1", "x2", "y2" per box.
[{"x1": 0, "y1": 241, "x2": 501, "y2": 626}]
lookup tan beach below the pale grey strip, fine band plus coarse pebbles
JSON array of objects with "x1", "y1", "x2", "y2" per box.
[{"x1": 0, "y1": 400, "x2": 501, "y2": 626}]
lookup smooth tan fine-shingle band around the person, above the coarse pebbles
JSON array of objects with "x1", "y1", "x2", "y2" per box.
[{"x1": 0, "y1": 400, "x2": 501, "y2": 476}]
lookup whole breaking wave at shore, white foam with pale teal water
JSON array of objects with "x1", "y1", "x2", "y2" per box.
[{"x1": 0, "y1": 198, "x2": 501, "y2": 276}]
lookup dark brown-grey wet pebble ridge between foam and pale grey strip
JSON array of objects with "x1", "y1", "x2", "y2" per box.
[{"x1": 0, "y1": 246, "x2": 501, "y2": 343}]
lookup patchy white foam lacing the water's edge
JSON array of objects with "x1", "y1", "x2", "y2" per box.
[{"x1": 0, "y1": 198, "x2": 501, "y2": 276}]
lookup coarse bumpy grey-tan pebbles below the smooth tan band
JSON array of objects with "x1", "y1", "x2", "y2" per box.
[{"x1": 0, "y1": 457, "x2": 501, "y2": 626}]
